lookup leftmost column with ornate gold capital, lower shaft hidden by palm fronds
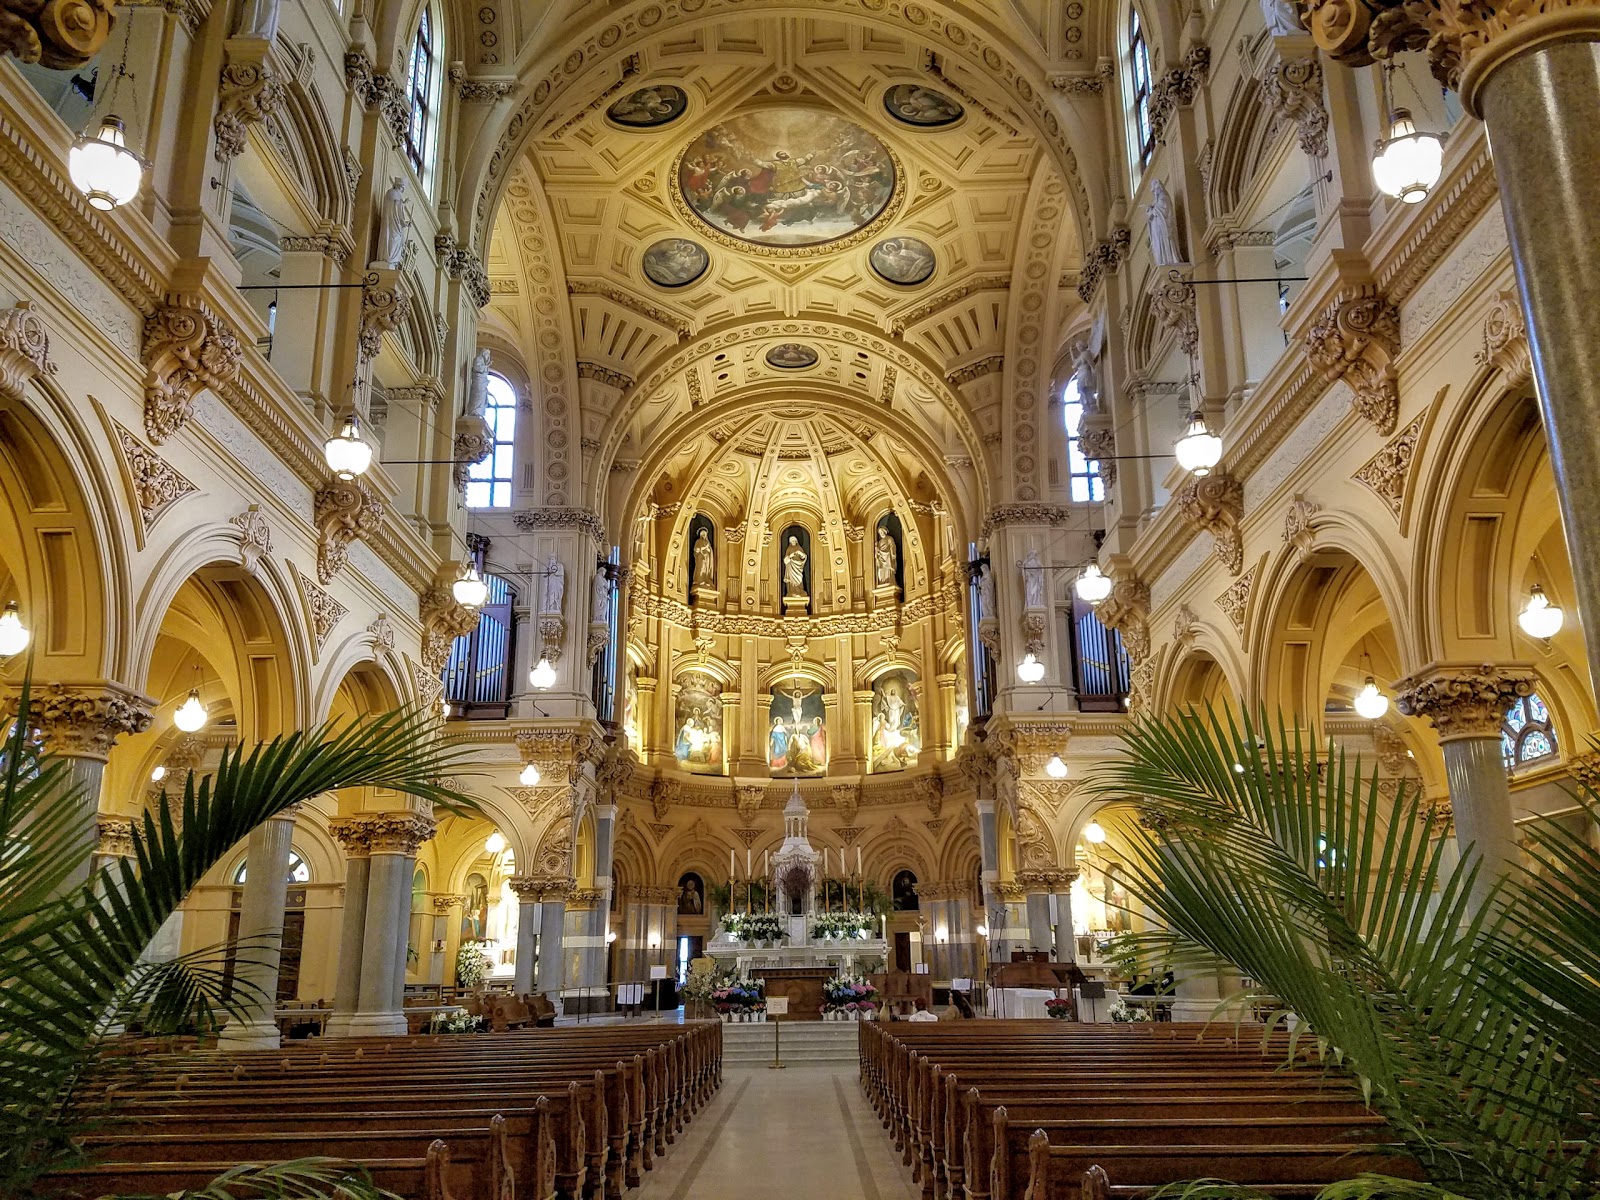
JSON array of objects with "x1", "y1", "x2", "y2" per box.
[{"x1": 29, "y1": 680, "x2": 155, "y2": 888}]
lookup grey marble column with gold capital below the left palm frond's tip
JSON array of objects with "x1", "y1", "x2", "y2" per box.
[{"x1": 349, "y1": 813, "x2": 434, "y2": 1037}]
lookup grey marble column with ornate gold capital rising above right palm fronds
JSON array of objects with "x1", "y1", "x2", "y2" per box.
[{"x1": 1395, "y1": 662, "x2": 1529, "y2": 901}]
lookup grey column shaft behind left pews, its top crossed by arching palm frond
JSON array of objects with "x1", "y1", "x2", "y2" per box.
[{"x1": 216, "y1": 805, "x2": 299, "y2": 1050}]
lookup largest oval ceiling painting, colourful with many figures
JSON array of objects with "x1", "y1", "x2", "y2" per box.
[{"x1": 678, "y1": 109, "x2": 894, "y2": 246}]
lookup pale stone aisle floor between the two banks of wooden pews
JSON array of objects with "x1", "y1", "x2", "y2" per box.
[{"x1": 635, "y1": 1062, "x2": 920, "y2": 1200}]
